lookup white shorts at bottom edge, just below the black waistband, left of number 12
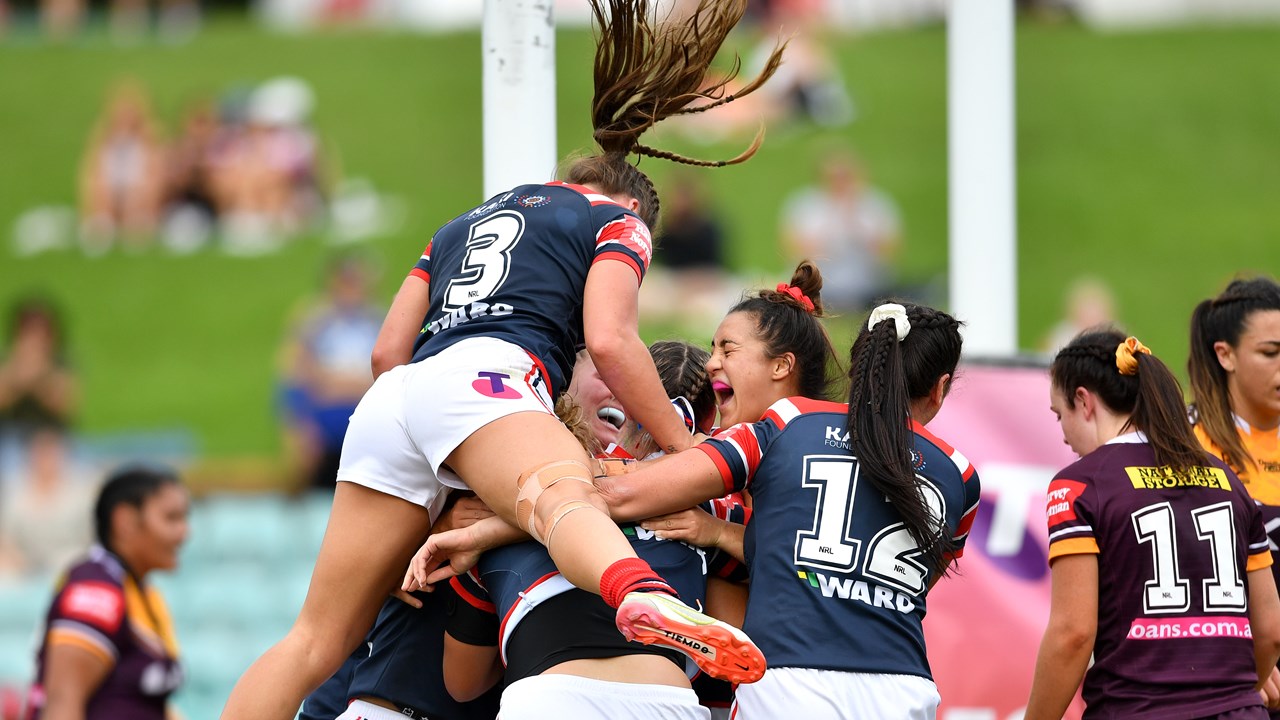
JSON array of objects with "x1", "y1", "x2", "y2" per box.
[{"x1": 498, "y1": 674, "x2": 710, "y2": 720}]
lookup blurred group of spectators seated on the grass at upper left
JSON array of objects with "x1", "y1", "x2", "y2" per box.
[{"x1": 79, "y1": 78, "x2": 325, "y2": 255}]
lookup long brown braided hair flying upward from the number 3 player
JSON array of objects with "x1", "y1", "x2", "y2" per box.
[{"x1": 564, "y1": 0, "x2": 783, "y2": 227}]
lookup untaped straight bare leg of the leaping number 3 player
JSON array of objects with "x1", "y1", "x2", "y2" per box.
[{"x1": 221, "y1": 483, "x2": 431, "y2": 720}]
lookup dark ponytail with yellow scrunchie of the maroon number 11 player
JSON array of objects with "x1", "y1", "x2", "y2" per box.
[{"x1": 1048, "y1": 328, "x2": 1207, "y2": 471}]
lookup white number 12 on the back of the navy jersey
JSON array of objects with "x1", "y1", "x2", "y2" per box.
[{"x1": 795, "y1": 455, "x2": 945, "y2": 594}]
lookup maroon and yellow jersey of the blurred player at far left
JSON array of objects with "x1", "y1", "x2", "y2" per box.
[{"x1": 27, "y1": 547, "x2": 182, "y2": 720}]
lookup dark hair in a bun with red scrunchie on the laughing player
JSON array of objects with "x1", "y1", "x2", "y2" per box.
[{"x1": 728, "y1": 260, "x2": 840, "y2": 400}]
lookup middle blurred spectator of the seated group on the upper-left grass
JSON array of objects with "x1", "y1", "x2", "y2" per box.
[{"x1": 163, "y1": 95, "x2": 221, "y2": 252}]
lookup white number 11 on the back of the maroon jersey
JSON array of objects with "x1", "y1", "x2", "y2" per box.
[{"x1": 1133, "y1": 502, "x2": 1248, "y2": 615}]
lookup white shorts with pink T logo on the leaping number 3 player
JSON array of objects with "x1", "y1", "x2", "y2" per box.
[{"x1": 338, "y1": 337, "x2": 554, "y2": 520}]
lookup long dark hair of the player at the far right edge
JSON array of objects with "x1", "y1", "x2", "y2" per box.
[{"x1": 1187, "y1": 278, "x2": 1280, "y2": 473}]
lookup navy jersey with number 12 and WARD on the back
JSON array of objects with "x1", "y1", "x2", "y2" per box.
[{"x1": 698, "y1": 397, "x2": 979, "y2": 678}]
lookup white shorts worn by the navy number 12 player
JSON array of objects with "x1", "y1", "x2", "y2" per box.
[{"x1": 731, "y1": 667, "x2": 942, "y2": 720}]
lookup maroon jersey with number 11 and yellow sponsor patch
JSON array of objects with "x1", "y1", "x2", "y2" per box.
[{"x1": 1046, "y1": 433, "x2": 1271, "y2": 720}]
